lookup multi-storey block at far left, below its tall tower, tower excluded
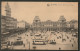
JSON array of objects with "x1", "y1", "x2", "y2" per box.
[{"x1": 1, "y1": 16, "x2": 17, "y2": 32}]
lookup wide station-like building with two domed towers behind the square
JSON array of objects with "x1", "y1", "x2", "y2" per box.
[{"x1": 31, "y1": 16, "x2": 78, "y2": 31}]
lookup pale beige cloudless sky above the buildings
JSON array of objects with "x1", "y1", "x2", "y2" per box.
[{"x1": 1, "y1": 2, "x2": 78, "y2": 23}]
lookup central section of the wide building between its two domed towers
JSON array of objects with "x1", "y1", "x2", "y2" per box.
[{"x1": 41, "y1": 20, "x2": 58, "y2": 31}]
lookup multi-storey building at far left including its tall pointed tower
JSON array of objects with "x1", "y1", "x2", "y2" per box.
[{"x1": 1, "y1": 3, "x2": 17, "y2": 34}]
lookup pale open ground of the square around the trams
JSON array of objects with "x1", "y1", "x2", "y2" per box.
[{"x1": 1, "y1": 31, "x2": 78, "y2": 50}]
